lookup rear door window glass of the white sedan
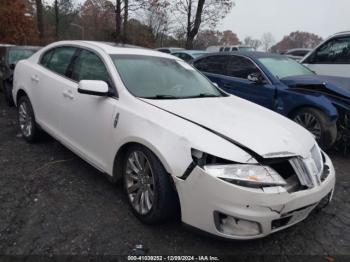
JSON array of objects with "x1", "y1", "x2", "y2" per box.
[{"x1": 41, "y1": 46, "x2": 77, "y2": 75}]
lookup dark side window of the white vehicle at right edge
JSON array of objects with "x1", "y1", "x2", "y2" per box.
[{"x1": 305, "y1": 37, "x2": 350, "y2": 64}]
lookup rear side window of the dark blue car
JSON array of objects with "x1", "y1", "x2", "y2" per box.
[{"x1": 194, "y1": 55, "x2": 230, "y2": 75}]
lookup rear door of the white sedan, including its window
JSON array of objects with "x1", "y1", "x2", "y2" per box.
[{"x1": 30, "y1": 46, "x2": 77, "y2": 138}]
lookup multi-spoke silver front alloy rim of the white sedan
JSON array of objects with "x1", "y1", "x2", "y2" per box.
[{"x1": 125, "y1": 151, "x2": 155, "y2": 215}]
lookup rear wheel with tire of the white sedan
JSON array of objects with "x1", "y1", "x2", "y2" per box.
[{"x1": 17, "y1": 95, "x2": 40, "y2": 143}]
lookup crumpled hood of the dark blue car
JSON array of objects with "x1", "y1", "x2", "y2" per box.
[{"x1": 280, "y1": 75, "x2": 350, "y2": 99}]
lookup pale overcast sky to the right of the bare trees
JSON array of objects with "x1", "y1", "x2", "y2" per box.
[{"x1": 218, "y1": 0, "x2": 350, "y2": 41}]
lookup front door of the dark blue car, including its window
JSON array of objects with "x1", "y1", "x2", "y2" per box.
[{"x1": 220, "y1": 55, "x2": 275, "y2": 109}]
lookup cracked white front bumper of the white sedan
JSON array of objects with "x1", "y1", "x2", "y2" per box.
[{"x1": 175, "y1": 151, "x2": 335, "y2": 240}]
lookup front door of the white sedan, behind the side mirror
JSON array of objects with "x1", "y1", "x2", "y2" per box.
[{"x1": 61, "y1": 49, "x2": 118, "y2": 171}]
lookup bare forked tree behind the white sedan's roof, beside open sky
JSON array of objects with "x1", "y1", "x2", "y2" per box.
[{"x1": 173, "y1": 0, "x2": 234, "y2": 49}]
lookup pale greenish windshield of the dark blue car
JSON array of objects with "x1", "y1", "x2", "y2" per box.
[{"x1": 259, "y1": 56, "x2": 315, "y2": 79}]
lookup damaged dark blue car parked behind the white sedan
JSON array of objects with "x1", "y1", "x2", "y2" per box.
[{"x1": 192, "y1": 52, "x2": 350, "y2": 149}]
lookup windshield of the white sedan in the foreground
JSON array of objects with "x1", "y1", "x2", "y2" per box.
[{"x1": 111, "y1": 55, "x2": 222, "y2": 99}]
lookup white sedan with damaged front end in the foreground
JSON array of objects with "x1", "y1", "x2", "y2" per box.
[{"x1": 13, "y1": 41, "x2": 335, "y2": 239}]
